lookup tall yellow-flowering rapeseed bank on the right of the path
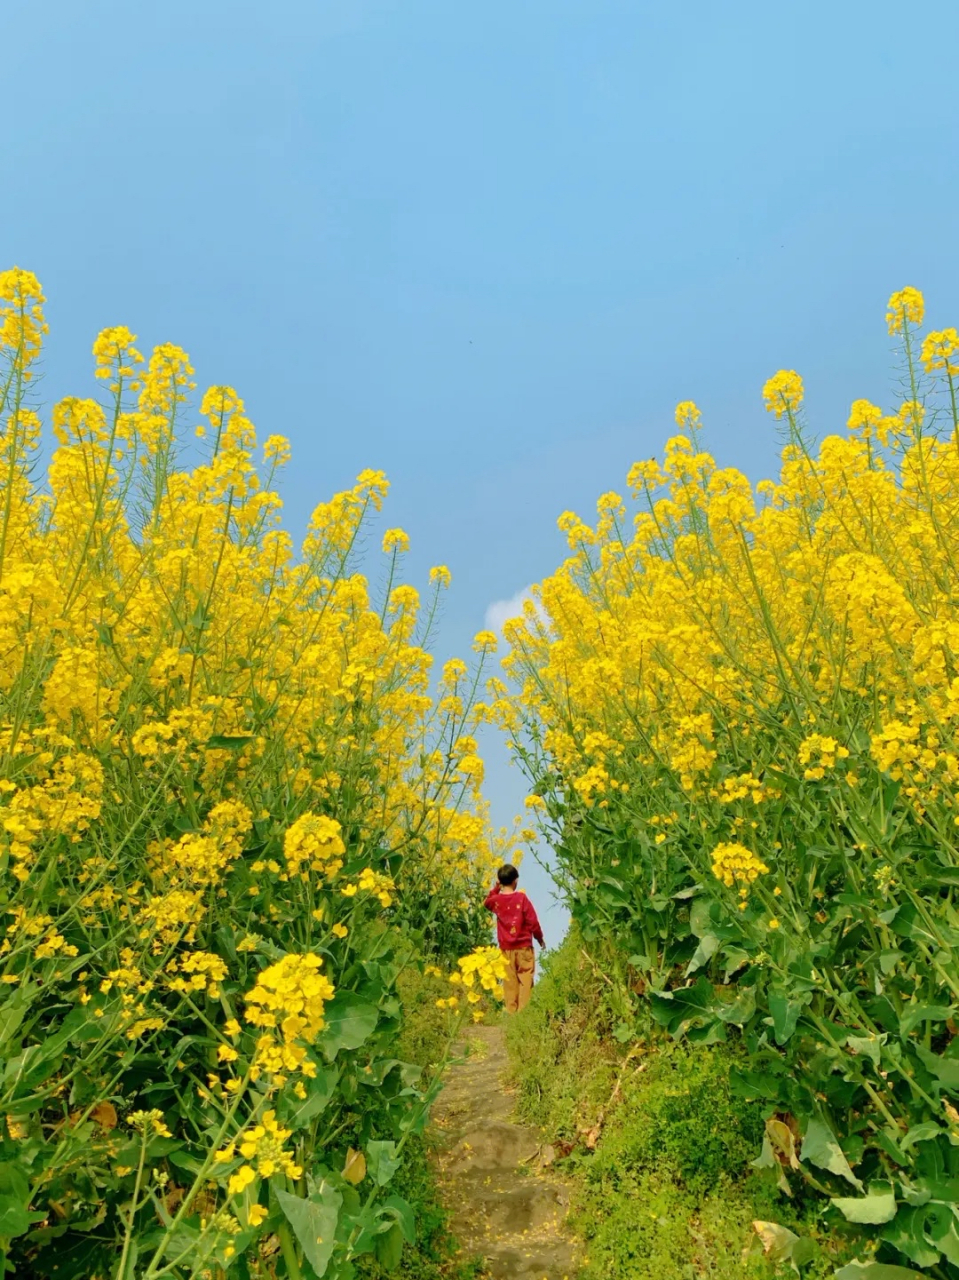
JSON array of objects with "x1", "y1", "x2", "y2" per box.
[{"x1": 503, "y1": 296, "x2": 959, "y2": 1276}]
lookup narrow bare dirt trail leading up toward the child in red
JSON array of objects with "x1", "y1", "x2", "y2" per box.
[{"x1": 433, "y1": 1025, "x2": 576, "y2": 1280}]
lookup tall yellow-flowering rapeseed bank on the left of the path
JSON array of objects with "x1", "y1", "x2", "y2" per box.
[{"x1": 0, "y1": 277, "x2": 501, "y2": 1280}]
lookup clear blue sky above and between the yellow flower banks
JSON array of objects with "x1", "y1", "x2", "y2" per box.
[{"x1": 0, "y1": 0, "x2": 959, "y2": 940}]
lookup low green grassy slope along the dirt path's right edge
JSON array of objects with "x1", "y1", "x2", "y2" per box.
[{"x1": 508, "y1": 931, "x2": 848, "y2": 1280}]
